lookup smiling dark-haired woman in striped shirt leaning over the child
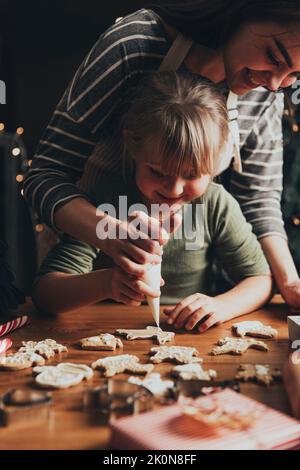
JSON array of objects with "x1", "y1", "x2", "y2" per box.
[{"x1": 25, "y1": 0, "x2": 300, "y2": 307}]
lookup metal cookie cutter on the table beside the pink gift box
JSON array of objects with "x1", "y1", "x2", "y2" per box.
[{"x1": 83, "y1": 379, "x2": 154, "y2": 419}]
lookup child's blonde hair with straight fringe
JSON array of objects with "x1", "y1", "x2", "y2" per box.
[{"x1": 123, "y1": 72, "x2": 228, "y2": 176}]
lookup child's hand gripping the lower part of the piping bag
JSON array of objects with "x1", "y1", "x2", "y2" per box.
[{"x1": 109, "y1": 267, "x2": 164, "y2": 306}]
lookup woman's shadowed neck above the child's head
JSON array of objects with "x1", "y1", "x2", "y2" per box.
[{"x1": 161, "y1": 19, "x2": 226, "y2": 83}]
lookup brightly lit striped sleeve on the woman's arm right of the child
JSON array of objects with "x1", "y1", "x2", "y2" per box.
[{"x1": 230, "y1": 90, "x2": 287, "y2": 239}]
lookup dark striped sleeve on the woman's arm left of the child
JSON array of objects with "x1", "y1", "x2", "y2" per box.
[{"x1": 24, "y1": 11, "x2": 166, "y2": 228}]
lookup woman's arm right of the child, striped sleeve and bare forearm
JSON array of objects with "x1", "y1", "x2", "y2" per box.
[{"x1": 231, "y1": 91, "x2": 300, "y2": 308}]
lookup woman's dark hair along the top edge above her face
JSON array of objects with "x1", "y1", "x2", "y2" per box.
[{"x1": 148, "y1": 0, "x2": 300, "y2": 48}]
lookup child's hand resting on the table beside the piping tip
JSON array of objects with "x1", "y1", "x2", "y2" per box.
[{"x1": 164, "y1": 293, "x2": 226, "y2": 333}]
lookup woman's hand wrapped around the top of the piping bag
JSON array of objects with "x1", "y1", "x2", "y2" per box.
[{"x1": 97, "y1": 211, "x2": 182, "y2": 277}]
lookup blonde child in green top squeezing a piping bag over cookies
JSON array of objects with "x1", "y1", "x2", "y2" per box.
[{"x1": 33, "y1": 72, "x2": 272, "y2": 332}]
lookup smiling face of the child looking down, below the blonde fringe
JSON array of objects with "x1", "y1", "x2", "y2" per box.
[{"x1": 135, "y1": 151, "x2": 210, "y2": 207}]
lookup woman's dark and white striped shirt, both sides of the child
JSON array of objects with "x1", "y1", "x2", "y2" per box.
[{"x1": 24, "y1": 9, "x2": 286, "y2": 238}]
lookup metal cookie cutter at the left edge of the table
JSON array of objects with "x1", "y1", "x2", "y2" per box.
[{"x1": 0, "y1": 389, "x2": 53, "y2": 426}]
